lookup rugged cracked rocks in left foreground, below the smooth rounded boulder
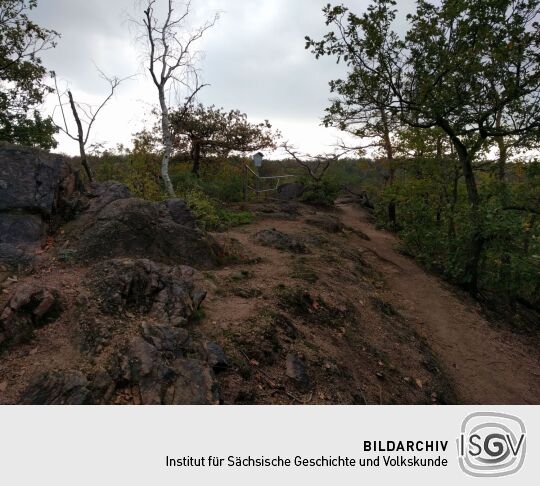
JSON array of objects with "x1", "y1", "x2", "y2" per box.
[{"x1": 13, "y1": 259, "x2": 224, "y2": 405}]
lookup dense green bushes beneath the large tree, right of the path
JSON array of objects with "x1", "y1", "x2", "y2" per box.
[{"x1": 376, "y1": 158, "x2": 540, "y2": 309}]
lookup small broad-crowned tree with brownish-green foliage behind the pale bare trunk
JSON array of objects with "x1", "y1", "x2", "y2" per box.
[{"x1": 171, "y1": 104, "x2": 279, "y2": 176}]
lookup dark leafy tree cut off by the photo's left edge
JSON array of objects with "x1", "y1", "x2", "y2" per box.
[{"x1": 0, "y1": 0, "x2": 58, "y2": 149}]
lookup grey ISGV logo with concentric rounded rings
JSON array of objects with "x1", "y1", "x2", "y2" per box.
[{"x1": 457, "y1": 412, "x2": 527, "y2": 477}]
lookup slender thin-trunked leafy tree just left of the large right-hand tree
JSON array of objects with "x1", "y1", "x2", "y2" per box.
[{"x1": 306, "y1": 3, "x2": 399, "y2": 222}]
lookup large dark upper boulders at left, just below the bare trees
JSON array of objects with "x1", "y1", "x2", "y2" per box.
[{"x1": 0, "y1": 144, "x2": 221, "y2": 270}]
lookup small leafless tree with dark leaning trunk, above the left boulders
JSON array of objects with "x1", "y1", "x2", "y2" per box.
[{"x1": 53, "y1": 71, "x2": 124, "y2": 182}]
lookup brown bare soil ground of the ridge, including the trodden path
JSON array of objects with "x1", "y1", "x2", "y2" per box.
[{"x1": 0, "y1": 201, "x2": 540, "y2": 405}]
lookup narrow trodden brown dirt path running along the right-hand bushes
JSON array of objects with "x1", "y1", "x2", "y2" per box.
[{"x1": 339, "y1": 199, "x2": 540, "y2": 404}]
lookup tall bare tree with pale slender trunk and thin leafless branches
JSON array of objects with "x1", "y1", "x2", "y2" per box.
[{"x1": 138, "y1": 0, "x2": 218, "y2": 197}]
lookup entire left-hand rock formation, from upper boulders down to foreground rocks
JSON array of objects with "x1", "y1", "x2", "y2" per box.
[{"x1": 0, "y1": 145, "x2": 227, "y2": 405}]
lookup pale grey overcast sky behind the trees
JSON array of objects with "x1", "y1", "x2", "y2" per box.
[{"x1": 33, "y1": 0, "x2": 413, "y2": 154}]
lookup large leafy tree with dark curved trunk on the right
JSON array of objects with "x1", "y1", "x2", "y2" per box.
[{"x1": 308, "y1": 0, "x2": 540, "y2": 293}]
